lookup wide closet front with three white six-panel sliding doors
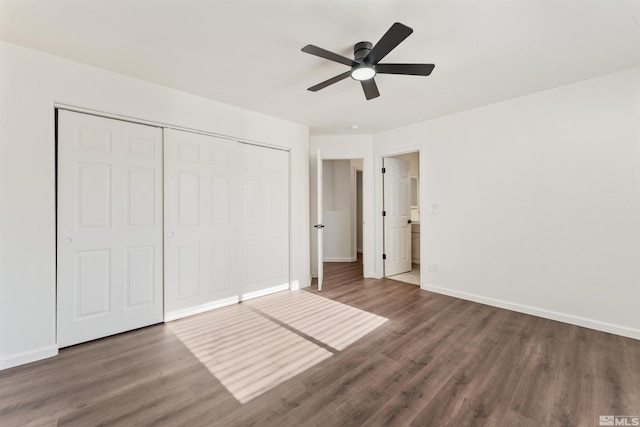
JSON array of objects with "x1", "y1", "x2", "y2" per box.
[{"x1": 57, "y1": 110, "x2": 289, "y2": 347}]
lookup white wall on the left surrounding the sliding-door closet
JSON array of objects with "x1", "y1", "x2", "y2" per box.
[{"x1": 0, "y1": 42, "x2": 310, "y2": 369}]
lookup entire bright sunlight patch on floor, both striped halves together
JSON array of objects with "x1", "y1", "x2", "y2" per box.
[{"x1": 167, "y1": 291, "x2": 387, "y2": 403}]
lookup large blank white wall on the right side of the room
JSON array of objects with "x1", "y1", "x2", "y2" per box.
[{"x1": 374, "y1": 68, "x2": 640, "y2": 338}]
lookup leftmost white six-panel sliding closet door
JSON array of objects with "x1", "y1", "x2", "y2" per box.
[{"x1": 57, "y1": 111, "x2": 163, "y2": 347}]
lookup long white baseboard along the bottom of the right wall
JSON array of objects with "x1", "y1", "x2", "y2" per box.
[{"x1": 421, "y1": 285, "x2": 640, "y2": 340}]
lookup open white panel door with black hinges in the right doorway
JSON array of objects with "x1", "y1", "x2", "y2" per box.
[{"x1": 383, "y1": 158, "x2": 411, "y2": 276}]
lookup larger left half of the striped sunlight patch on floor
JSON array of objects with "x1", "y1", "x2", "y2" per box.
[{"x1": 168, "y1": 305, "x2": 332, "y2": 403}]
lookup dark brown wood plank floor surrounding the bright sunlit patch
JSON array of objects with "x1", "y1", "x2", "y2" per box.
[{"x1": 0, "y1": 263, "x2": 640, "y2": 427}]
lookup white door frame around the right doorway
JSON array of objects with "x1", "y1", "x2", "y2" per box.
[{"x1": 374, "y1": 145, "x2": 427, "y2": 288}]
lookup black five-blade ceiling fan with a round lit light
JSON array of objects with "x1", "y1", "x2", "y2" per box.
[{"x1": 302, "y1": 22, "x2": 435, "y2": 100}]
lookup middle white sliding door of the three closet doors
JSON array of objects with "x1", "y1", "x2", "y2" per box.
[{"x1": 165, "y1": 129, "x2": 241, "y2": 320}]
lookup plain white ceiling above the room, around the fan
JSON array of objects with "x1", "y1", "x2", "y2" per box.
[{"x1": 0, "y1": 0, "x2": 640, "y2": 134}]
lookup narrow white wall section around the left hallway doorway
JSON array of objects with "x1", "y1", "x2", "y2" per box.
[{"x1": 309, "y1": 135, "x2": 382, "y2": 277}]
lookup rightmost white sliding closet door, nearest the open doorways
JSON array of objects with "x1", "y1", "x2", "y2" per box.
[{"x1": 241, "y1": 144, "x2": 289, "y2": 300}]
